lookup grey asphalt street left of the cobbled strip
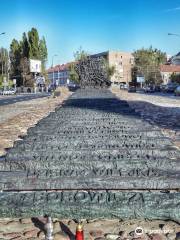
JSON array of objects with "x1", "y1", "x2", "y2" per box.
[{"x1": 0, "y1": 93, "x2": 50, "y2": 106}]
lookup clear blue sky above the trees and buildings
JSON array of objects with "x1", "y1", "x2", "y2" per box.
[{"x1": 0, "y1": 0, "x2": 180, "y2": 65}]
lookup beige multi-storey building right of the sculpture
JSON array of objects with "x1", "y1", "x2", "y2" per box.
[{"x1": 91, "y1": 51, "x2": 134, "y2": 84}]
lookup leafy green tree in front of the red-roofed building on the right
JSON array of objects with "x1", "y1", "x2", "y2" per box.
[{"x1": 133, "y1": 47, "x2": 166, "y2": 85}]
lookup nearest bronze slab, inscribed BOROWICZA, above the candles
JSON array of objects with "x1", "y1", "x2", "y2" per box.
[{"x1": 0, "y1": 190, "x2": 180, "y2": 223}]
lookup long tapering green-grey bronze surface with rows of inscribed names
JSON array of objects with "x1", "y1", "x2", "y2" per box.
[{"x1": 0, "y1": 89, "x2": 180, "y2": 221}]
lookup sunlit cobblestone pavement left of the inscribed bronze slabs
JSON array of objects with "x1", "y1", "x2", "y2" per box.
[{"x1": 0, "y1": 88, "x2": 70, "y2": 155}]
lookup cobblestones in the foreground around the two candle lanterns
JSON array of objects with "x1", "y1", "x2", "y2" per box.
[{"x1": 0, "y1": 217, "x2": 180, "y2": 240}]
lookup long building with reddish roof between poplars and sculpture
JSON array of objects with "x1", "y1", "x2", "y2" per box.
[{"x1": 48, "y1": 63, "x2": 69, "y2": 85}]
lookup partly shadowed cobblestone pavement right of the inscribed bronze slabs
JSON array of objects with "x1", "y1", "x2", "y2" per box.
[{"x1": 111, "y1": 87, "x2": 180, "y2": 147}]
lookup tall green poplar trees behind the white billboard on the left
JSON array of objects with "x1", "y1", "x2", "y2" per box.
[{"x1": 10, "y1": 28, "x2": 48, "y2": 86}]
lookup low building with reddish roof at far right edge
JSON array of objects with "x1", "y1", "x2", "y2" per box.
[{"x1": 160, "y1": 65, "x2": 180, "y2": 84}]
